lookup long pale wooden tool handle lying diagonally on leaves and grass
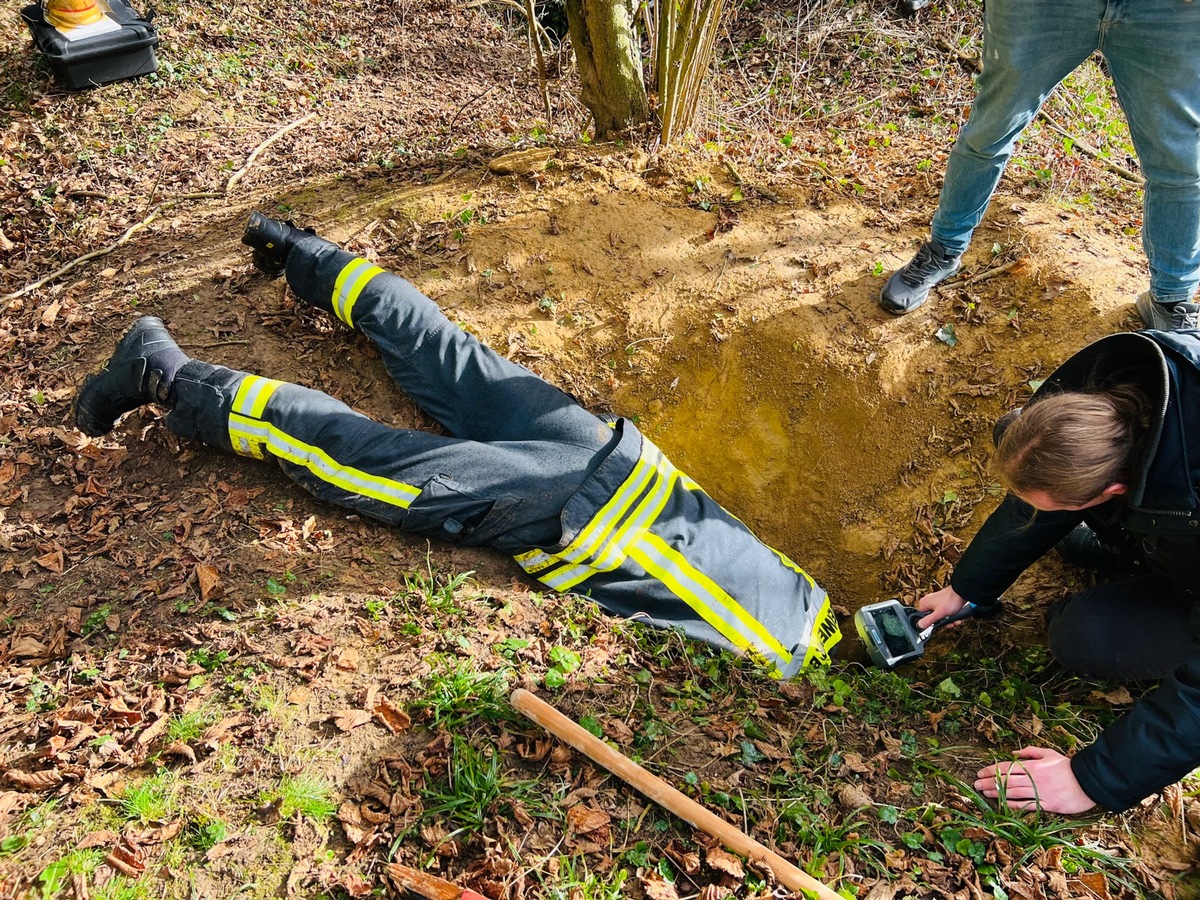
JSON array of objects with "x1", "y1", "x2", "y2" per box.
[{"x1": 511, "y1": 688, "x2": 845, "y2": 900}]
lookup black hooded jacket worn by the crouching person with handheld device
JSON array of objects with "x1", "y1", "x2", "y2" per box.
[{"x1": 950, "y1": 331, "x2": 1200, "y2": 811}]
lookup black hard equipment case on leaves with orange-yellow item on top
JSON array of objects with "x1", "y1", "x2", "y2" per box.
[{"x1": 20, "y1": 0, "x2": 158, "y2": 89}]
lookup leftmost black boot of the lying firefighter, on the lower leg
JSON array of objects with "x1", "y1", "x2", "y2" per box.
[{"x1": 74, "y1": 316, "x2": 187, "y2": 438}]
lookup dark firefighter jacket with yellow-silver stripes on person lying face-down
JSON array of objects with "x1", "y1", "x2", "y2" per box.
[{"x1": 515, "y1": 419, "x2": 841, "y2": 678}]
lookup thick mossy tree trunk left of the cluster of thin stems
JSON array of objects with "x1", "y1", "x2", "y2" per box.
[{"x1": 564, "y1": 0, "x2": 650, "y2": 140}]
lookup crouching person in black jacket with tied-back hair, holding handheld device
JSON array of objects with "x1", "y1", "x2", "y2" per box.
[{"x1": 918, "y1": 331, "x2": 1200, "y2": 814}]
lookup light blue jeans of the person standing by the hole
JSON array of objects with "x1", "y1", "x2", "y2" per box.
[{"x1": 932, "y1": 0, "x2": 1200, "y2": 302}]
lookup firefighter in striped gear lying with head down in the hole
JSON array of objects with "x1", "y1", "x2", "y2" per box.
[{"x1": 74, "y1": 214, "x2": 841, "y2": 677}]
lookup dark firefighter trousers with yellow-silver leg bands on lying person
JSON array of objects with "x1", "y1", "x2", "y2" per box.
[{"x1": 167, "y1": 236, "x2": 618, "y2": 553}]
